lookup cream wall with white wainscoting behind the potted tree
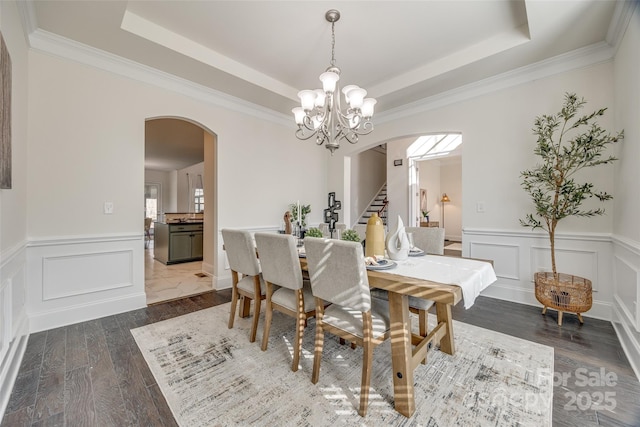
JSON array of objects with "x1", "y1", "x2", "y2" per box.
[{"x1": 330, "y1": 61, "x2": 620, "y2": 326}]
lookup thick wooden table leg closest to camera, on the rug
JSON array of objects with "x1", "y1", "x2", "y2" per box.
[{"x1": 389, "y1": 291, "x2": 416, "y2": 417}]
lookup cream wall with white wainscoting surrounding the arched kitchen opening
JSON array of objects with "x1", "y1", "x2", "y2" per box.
[{"x1": 27, "y1": 44, "x2": 328, "y2": 331}]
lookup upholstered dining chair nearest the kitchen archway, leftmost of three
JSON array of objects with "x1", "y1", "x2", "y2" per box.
[{"x1": 221, "y1": 229, "x2": 266, "y2": 342}]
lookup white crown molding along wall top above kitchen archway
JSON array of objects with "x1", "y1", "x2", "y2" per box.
[{"x1": 29, "y1": 29, "x2": 291, "y2": 126}]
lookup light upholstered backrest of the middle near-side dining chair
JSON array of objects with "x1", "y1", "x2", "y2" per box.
[{"x1": 255, "y1": 233, "x2": 303, "y2": 290}]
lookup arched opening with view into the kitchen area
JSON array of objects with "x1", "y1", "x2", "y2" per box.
[{"x1": 144, "y1": 117, "x2": 217, "y2": 304}]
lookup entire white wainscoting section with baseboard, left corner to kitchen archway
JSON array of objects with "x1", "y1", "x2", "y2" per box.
[{"x1": 27, "y1": 234, "x2": 146, "y2": 332}]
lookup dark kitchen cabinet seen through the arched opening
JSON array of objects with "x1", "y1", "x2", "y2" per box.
[{"x1": 153, "y1": 222, "x2": 204, "y2": 264}]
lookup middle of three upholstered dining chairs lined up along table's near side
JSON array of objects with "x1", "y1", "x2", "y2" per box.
[{"x1": 255, "y1": 233, "x2": 316, "y2": 372}]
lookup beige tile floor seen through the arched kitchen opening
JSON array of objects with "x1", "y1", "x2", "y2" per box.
[{"x1": 144, "y1": 240, "x2": 213, "y2": 305}]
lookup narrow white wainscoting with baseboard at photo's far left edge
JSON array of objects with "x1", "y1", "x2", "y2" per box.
[{"x1": 0, "y1": 244, "x2": 29, "y2": 422}]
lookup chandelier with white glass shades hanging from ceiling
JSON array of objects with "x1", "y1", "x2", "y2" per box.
[{"x1": 291, "y1": 9, "x2": 377, "y2": 155}]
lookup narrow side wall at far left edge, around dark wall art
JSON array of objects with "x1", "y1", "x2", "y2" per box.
[{"x1": 0, "y1": 1, "x2": 29, "y2": 414}]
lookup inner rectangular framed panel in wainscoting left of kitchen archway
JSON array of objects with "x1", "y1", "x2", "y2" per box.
[{"x1": 42, "y1": 250, "x2": 133, "y2": 301}]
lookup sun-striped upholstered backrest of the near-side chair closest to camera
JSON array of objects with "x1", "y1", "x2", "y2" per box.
[{"x1": 304, "y1": 237, "x2": 371, "y2": 312}]
